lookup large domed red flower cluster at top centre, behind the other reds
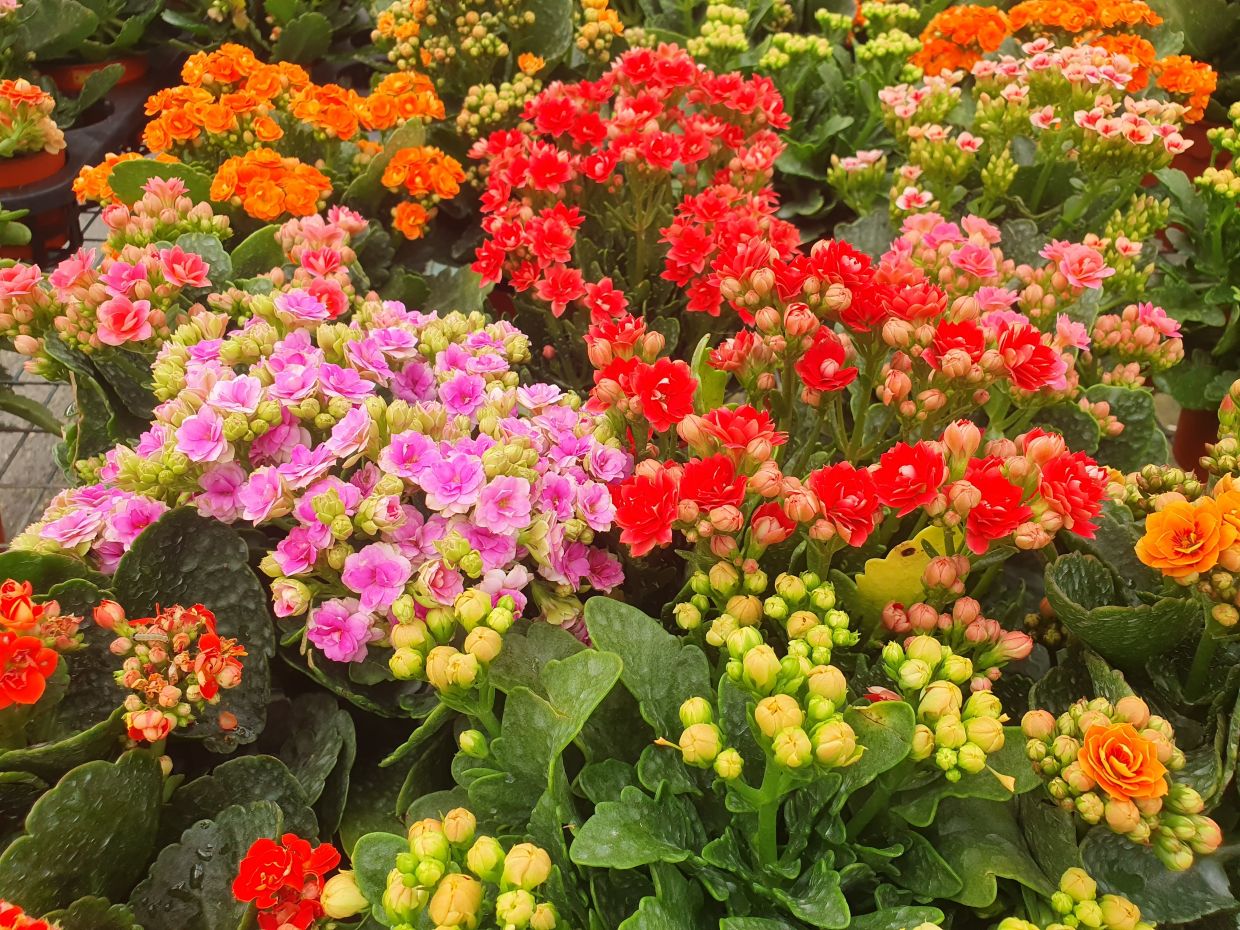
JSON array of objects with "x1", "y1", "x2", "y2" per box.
[{"x1": 471, "y1": 45, "x2": 797, "y2": 327}]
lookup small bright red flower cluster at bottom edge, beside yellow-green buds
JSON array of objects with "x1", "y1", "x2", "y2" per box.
[{"x1": 232, "y1": 833, "x2": 340, "y2": 930}]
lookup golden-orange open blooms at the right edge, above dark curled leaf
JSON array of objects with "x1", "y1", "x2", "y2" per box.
[{"x1": 1137, "y1": 476, "x2": 1240, "y2": 583}]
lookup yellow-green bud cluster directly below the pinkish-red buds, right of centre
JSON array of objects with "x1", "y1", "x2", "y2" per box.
[{"x1": 909, "y1": 680, "x2": 1007, "y2": 781}]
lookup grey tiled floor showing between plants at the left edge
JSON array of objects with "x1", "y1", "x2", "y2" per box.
[{"x1": 0, "y1": 215, "x2": 103, "y2": 538}]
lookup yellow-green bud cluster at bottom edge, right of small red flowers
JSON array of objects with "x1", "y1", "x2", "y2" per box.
[{"x1": 383, "y1": 807, "x2": 560, "y2": 930}]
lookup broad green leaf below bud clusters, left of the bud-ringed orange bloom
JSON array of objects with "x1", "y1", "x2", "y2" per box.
[{"x1": 935, "y1": 797, "x2": 1058, "y2": 908}]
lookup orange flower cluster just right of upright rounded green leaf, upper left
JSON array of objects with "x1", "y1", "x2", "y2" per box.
[{"x1": 211, "y1": 149, "x2": 331, "y2": 221}]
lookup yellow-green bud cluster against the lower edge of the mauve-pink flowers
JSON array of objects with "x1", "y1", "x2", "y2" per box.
[{"x1": 388, "y1": 588, "x2": 516, "y2": 694}]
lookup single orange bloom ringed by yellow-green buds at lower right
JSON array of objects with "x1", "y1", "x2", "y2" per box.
[{"x1": 1021, "y1": 696, "x2": 1223, "y2": 870}]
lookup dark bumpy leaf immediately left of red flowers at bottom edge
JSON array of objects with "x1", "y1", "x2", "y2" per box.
[{"x1": 129, "y1": 801, "x2": 283, "y2": 930}]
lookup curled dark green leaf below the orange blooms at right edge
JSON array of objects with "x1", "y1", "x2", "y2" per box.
[{"x1": 1045, "y1": 552, "x2": 1202, "y2": 668}]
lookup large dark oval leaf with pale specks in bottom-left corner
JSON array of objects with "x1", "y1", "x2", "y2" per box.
[{"x1": 0, "y1": 750, "x2": 164, "y2": 914}]
